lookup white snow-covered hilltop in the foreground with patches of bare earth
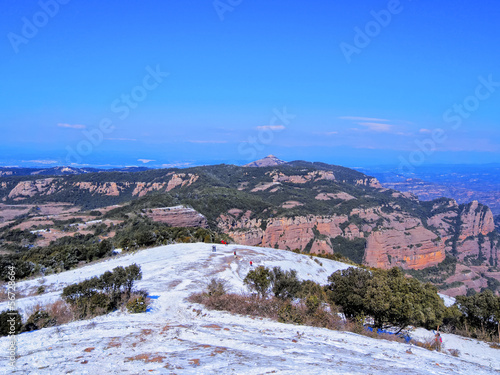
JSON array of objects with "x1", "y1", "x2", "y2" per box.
[{"x1": 0, "y1": 243, "x2": 500, "y2": 375}]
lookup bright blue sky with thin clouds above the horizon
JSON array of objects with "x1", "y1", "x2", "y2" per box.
[{"x1": 0, "y1": 0, "x2": 500, "y2": 169}]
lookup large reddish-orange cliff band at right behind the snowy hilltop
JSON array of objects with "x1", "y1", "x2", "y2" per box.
[{"x1": 218, "y1": 204, "x2": 499, "y2": 269}]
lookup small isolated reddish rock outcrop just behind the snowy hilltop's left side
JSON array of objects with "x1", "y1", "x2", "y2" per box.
[{"x1": 146, "y1": 206, "x2": 208, "y2": 228}]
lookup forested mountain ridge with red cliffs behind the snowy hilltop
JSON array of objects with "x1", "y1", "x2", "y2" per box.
[{"x1": 0, "y1": 161, "x2": 500, "y2": 295}]
